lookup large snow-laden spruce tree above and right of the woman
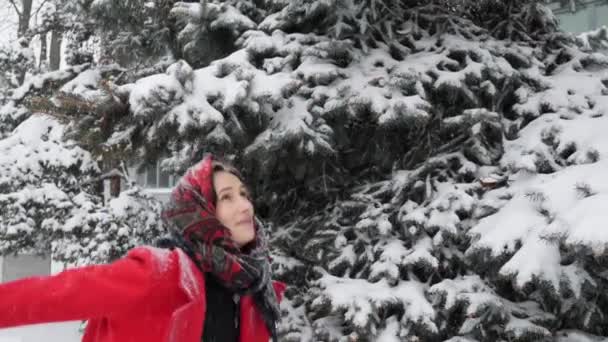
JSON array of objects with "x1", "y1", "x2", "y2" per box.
[{"x1": 58, "y1": 0, "x2": 608, "y2": 341}]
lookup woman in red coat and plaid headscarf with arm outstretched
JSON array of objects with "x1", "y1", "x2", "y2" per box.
[{"x1": 0, "y1": 156, "x2": 285, "y2": 342}]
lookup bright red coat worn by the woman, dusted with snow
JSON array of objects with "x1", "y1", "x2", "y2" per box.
[{"x1": 0, "y1": 247, "x2": 285, "y2": 342}]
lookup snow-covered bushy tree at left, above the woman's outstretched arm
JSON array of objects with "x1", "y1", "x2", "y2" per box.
[{"x1": 0, "y1": 64, "x2": 161, "y2": 264}]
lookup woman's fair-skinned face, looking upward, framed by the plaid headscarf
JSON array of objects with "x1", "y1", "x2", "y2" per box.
[{"x1": 213, "y1": 171, "x2": 255, "y2": 247}]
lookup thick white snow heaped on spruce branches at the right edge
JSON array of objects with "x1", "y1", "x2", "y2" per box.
[{"x1": 467, "y1": 39, "x2": 608, "y2": 295}]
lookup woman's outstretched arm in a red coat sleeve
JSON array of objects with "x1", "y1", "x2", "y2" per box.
[{"x1": 0, "y1": 248, "x2": 180, "y2": 328}]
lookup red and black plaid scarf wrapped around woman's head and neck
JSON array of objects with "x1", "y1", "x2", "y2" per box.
[{"x1": 158, "y1": 156, "x2": 281, "y2": 341}]
